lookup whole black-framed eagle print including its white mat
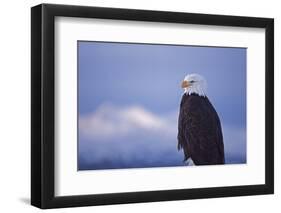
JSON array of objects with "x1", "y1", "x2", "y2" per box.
[{"x1": 31, "y1": 4, "x2": 274, "y2": 208}]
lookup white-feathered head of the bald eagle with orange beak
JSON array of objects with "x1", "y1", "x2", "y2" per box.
[{"x1": 181, "y1": 74, "x2": 207, "y2": 96}]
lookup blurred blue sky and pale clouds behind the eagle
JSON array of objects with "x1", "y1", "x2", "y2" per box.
[{"x1": 78, "y1": 41, "x2": 246, "y2": 170}]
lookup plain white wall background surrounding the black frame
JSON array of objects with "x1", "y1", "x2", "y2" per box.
[{"x1": 0, "y1": 0, "x2": 276, "y2": 213}]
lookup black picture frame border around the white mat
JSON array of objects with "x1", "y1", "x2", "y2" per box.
[{"x1": 31, "y1": 4, "x2": 274, "y2": 209}]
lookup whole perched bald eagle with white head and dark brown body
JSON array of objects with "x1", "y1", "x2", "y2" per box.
[{"x1": 178, "y1": 74, "x2": 225, "y2": 165}]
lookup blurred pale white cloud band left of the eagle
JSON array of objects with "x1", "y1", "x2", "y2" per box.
[{"x1": 79, "y1": 103, "x2": 177, "y2": 139}]
